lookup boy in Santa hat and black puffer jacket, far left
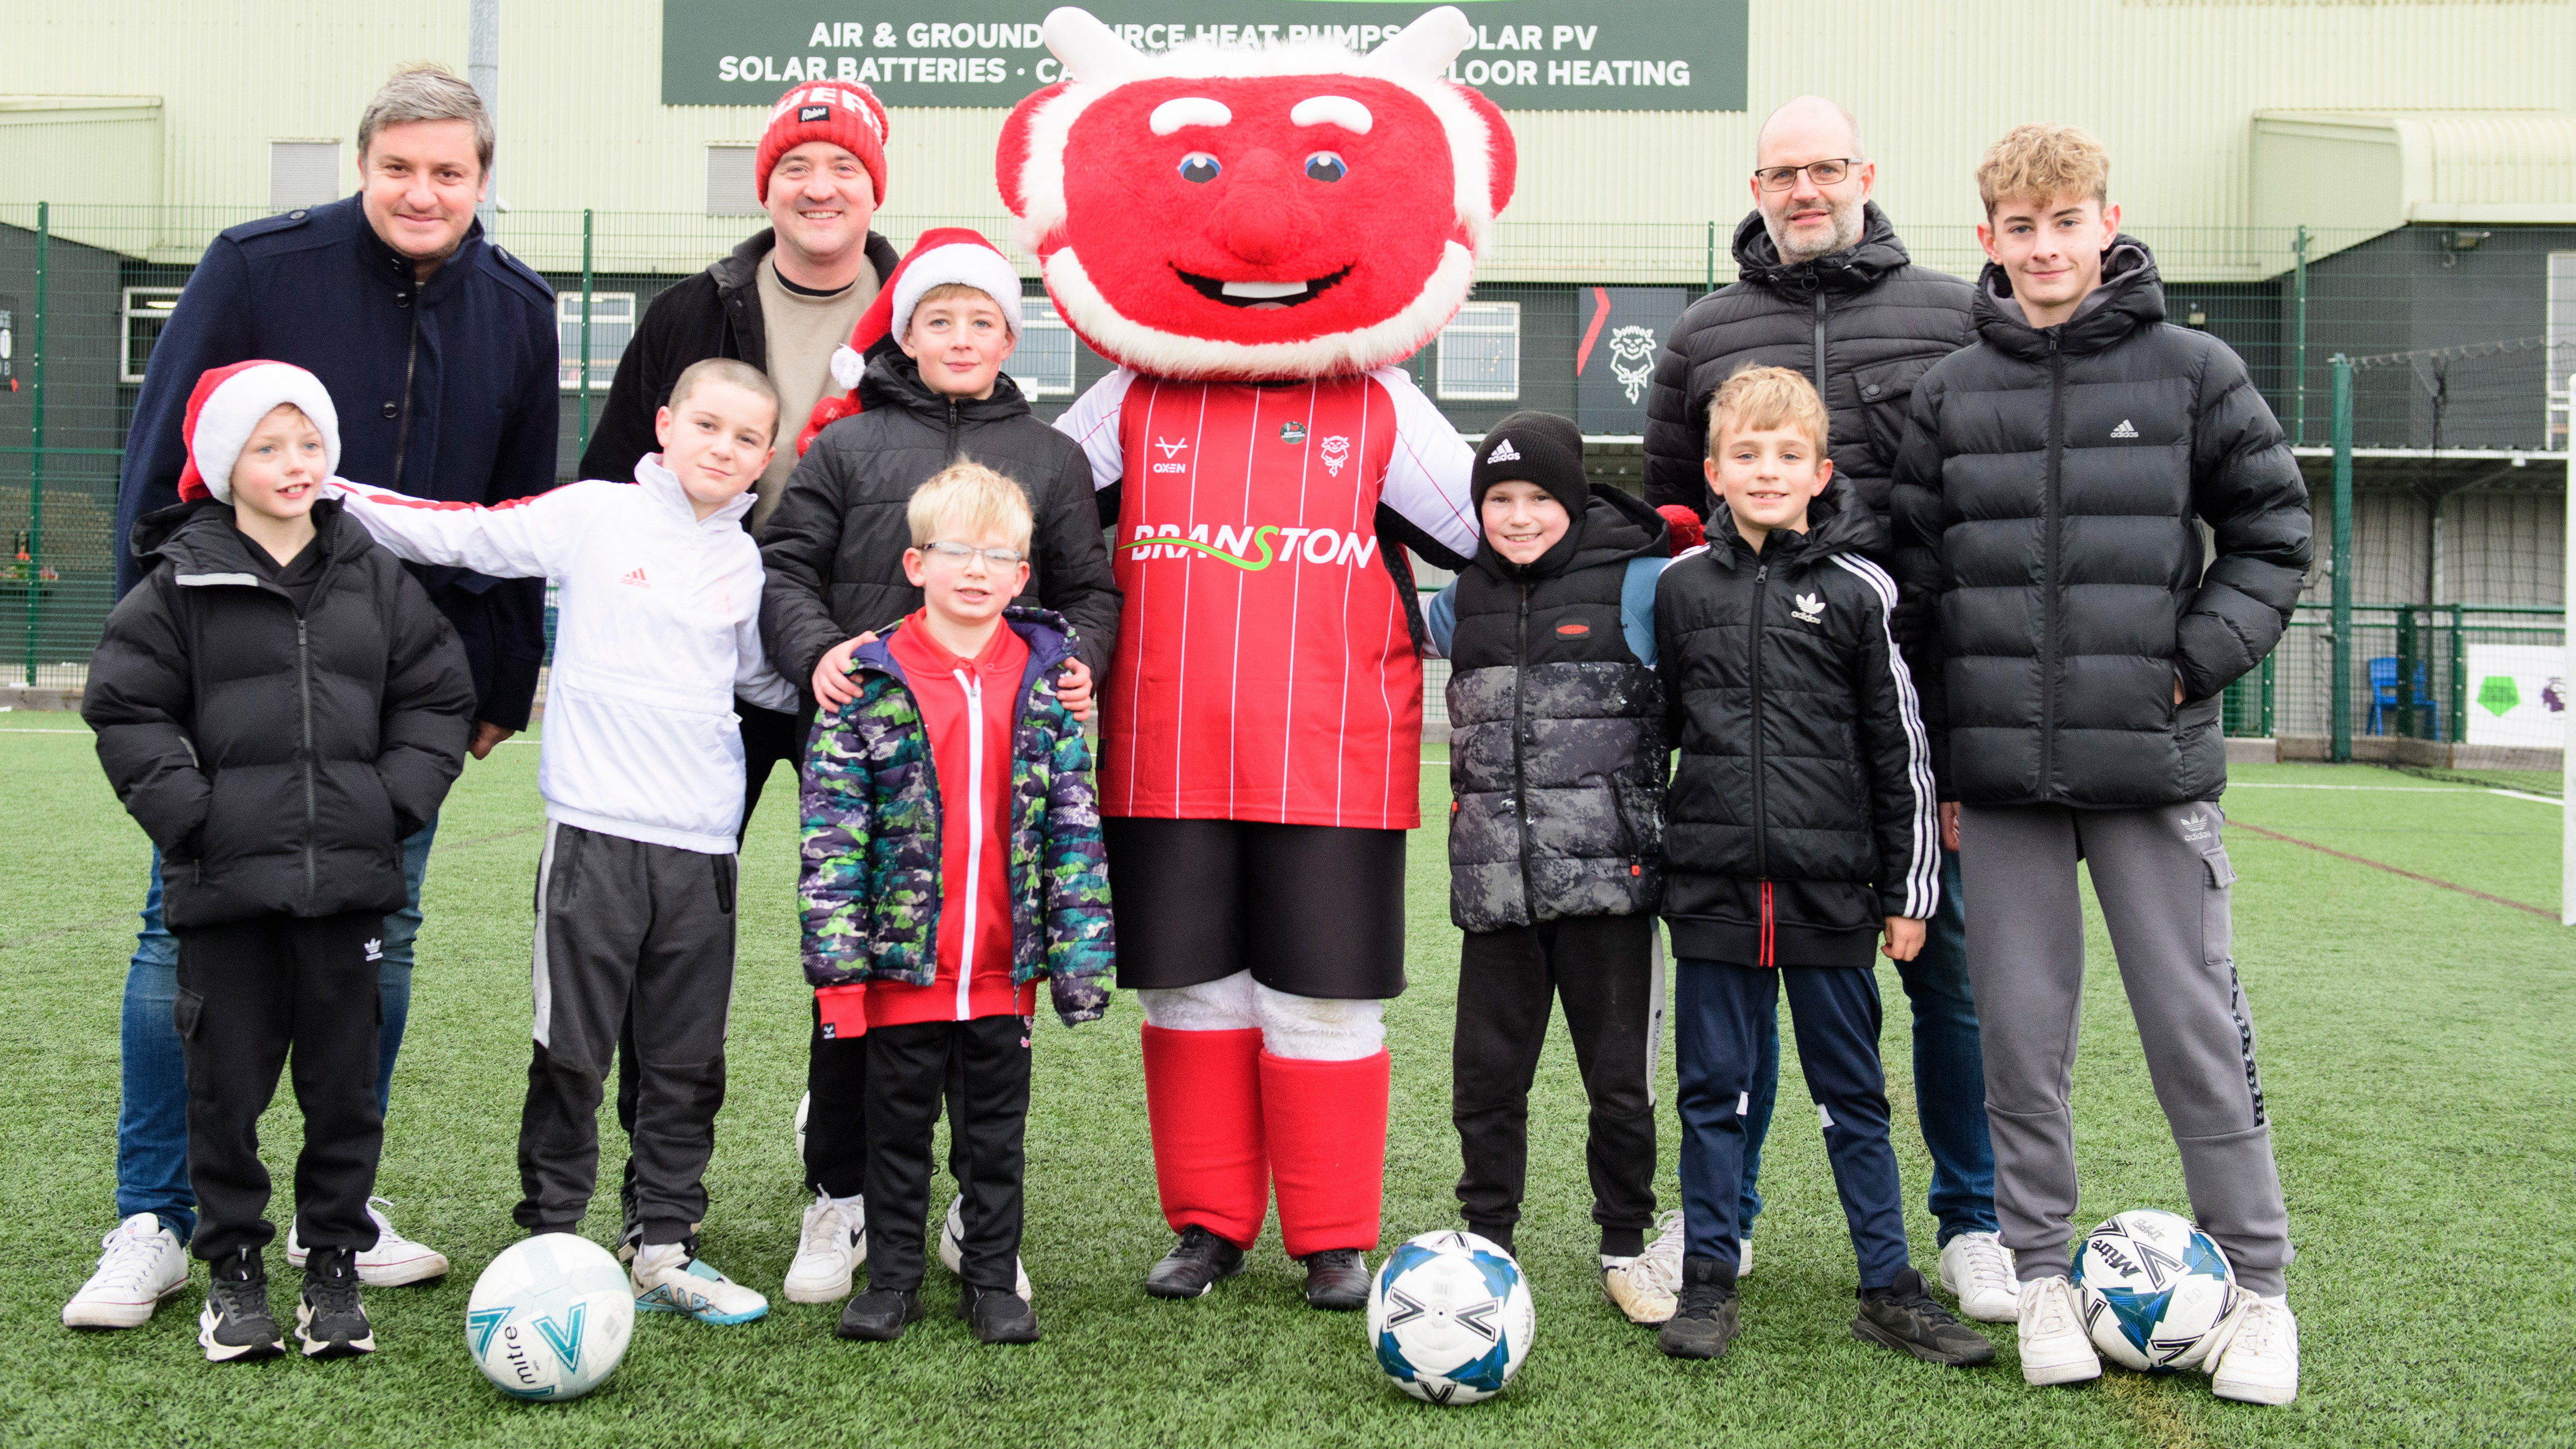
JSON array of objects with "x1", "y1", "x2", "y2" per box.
[{"x1": 80, "y1": 363, "x2": 474, "y2": 1361}]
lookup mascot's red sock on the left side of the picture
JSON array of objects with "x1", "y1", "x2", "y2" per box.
[{"x1": 1144, "y1": 1025, "x2": 1270, "y2": 1248}]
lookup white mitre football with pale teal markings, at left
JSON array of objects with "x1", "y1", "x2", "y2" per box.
[{"x1": 466, "y1": 1233, "x2": 636, "y2": 1400}]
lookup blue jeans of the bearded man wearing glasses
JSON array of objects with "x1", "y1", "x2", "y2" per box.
[{"x1": 1736, "y1": 849, "x2": 1994, "y2": 1246}]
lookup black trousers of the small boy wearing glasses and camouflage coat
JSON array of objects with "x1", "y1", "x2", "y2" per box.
[{"x1": 860, "y1": 1016, "x2": 1031, "y2": 1292}]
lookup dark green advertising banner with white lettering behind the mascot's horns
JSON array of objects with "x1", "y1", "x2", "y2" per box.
[{"x1": 662, "y1": 0, "x2": 1752, "y2": 111}]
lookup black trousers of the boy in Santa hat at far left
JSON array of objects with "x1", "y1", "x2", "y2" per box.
[{"x1": 170, "y1": 911, "x2": 384, "y2": 1261}]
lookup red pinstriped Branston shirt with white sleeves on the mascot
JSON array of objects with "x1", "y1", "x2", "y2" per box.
[{"x1": 1056, "y1": 368, "x2": 1476, "y2": 829}]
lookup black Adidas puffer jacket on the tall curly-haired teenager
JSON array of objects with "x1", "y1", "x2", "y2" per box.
[{"x1": 1896, "y1": 237, "x2": 2313, "y2": 808}]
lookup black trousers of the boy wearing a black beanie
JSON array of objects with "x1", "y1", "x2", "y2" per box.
[{"x1": 1450, "y1": 916, "x2": 1659, "y2": 1256}]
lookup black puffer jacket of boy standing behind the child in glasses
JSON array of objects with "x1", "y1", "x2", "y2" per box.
[{"x1": 760, "y1": 350, "x2": 1118, "y2": 695}]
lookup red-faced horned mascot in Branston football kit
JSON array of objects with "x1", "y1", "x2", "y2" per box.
[{"x1": 999, "y1": 8, "x2": 1512, "y2": 1307}]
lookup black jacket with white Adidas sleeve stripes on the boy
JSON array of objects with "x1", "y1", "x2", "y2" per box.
[{"x1": 1654, "y1": 487, "x2": 1940, "y2": 965}]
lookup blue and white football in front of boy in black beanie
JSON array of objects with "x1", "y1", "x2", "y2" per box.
[{"x1": 1368, "y1": 1230, "x2": 1538, "y2": 1405}]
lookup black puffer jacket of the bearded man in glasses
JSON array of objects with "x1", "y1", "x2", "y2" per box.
[{"x1": 1646, "y1": 203, "x2": 1976, "y2": 533}]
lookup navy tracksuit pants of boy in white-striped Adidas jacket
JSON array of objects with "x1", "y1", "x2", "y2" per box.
[{"x1": 1672, "y1": 960, "x2": 1906, "y2": 1287}]
